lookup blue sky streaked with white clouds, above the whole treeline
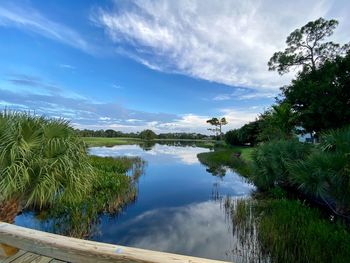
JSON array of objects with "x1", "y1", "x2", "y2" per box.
[{"x1": 0, "y1": 0, "x2": 350, "y2": 133}]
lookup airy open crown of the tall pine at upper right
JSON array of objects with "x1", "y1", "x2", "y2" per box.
[{"x1": 268, "y1": 18, "x2": 349, "y2": 74}]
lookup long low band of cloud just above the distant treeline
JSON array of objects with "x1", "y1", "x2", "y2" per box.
[{"x1": 0, "y1": 74, "x2": 258, "y2": 133}]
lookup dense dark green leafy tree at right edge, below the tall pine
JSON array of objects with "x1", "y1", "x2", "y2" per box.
[{"x1": 282, "y1": 52, "x2": 350, "y2": 136}]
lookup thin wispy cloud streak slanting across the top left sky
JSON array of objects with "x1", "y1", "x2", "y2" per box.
[{"x1": 0, "y1": 4, "x2": 96, "y2": 54}]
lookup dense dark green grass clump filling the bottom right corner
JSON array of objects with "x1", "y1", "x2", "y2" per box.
[{"x1": 258, "y1": 199, "x2": 350, "y2": 263}]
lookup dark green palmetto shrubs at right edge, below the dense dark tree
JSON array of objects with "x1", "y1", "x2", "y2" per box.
[{"x1": 288, "y1": 127, "x2": 350, "y2": 214}]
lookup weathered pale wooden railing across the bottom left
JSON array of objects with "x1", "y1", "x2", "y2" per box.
[{"x1": 0, "y1": 222, "x2": 230, "y2": 263}]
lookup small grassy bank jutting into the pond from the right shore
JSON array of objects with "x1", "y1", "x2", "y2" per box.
[{"x1": 197, "y1": 146, "x2": 254, "y2": 177}]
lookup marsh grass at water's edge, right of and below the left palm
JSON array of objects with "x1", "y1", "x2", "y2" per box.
[{"x1": 40, "y1": 156, "x2": 145, "y2": 238}]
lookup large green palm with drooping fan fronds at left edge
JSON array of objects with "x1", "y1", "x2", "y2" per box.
[{"x1": 0, "y1": 111, "x2": 93, "y2": 212}]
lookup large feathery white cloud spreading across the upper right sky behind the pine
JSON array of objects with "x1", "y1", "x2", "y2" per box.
[{"x1": 93, "y1": 0, "x2": 350, "y2": 89}]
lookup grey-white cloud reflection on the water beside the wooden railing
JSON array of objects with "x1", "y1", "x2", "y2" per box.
[{"x1": 98, "y1": 201, "x2": 234, "y2": 260}]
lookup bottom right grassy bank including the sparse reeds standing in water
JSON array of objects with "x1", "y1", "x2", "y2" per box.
[{"x1": 225, "y1": 198, "x2": 350, "y2": 263}]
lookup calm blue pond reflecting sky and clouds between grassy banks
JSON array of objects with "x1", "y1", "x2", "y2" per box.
[{"x1": 15, "y1": 144, "x2": 254, "y2": 262}]
